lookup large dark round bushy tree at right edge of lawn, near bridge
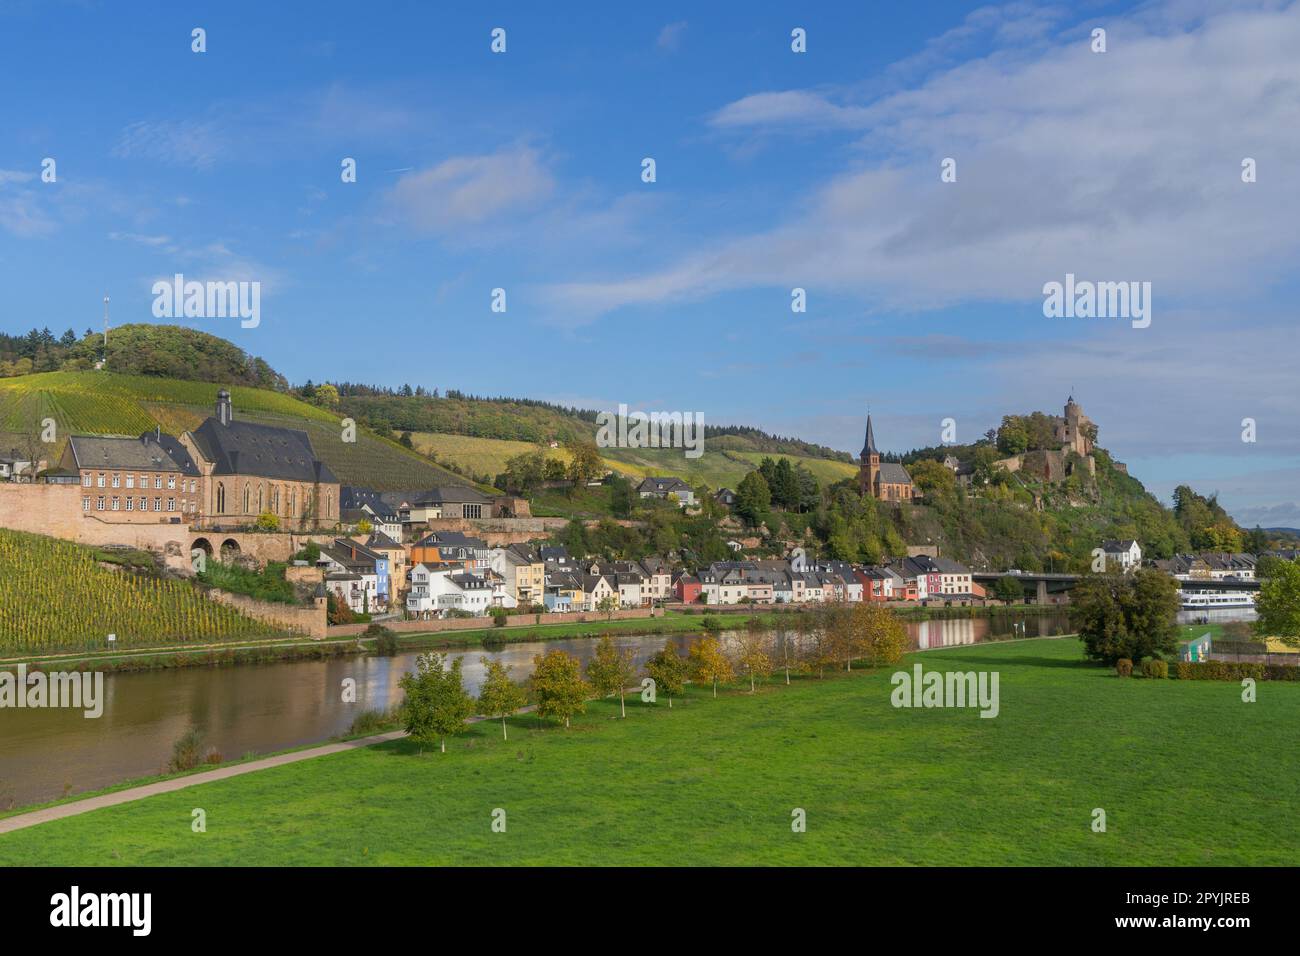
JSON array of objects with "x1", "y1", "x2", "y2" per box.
[{"x1": 1071, "y1": 568, "x2": 1179, "y2": 666}]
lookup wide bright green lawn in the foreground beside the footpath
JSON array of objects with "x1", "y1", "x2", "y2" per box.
[{"x1": 0, "y1": 639, "x2": 1300, "y2": 865}]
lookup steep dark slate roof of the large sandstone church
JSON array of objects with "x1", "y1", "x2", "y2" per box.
[{"x1": 191, "y1": 418, "x2": 338, "y2": 484}]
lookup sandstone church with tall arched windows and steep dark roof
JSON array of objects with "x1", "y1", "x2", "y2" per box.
[{"x1": 178, "y1": 389, "x2": 339, "y2": 529}]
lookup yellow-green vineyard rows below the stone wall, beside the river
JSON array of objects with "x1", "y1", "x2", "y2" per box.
[{"x1": 0, "y1": 528, "x2": 278, "y2": 654}]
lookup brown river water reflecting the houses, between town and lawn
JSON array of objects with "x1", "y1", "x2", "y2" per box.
[{"x1": 0, "y1": 611, "x2": 1069, "y2": 808}]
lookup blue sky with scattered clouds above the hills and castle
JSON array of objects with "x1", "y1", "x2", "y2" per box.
[{"x1": 0, "y1": 0, "x2": 1300, "y2": 525}]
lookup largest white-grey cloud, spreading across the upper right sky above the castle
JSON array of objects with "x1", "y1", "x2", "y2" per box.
[{"x1": 551, "y1": 5, "x2": 1300, "y2": 320}]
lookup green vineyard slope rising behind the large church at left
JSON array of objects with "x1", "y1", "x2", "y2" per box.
[{"x1": 0, "y1": 372, "x2": 478, "y2": 490}]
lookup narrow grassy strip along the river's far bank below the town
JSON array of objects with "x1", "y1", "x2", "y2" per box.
[{"x1": 0, "y1": 605, "x2": 1065, "y2": 674}]
